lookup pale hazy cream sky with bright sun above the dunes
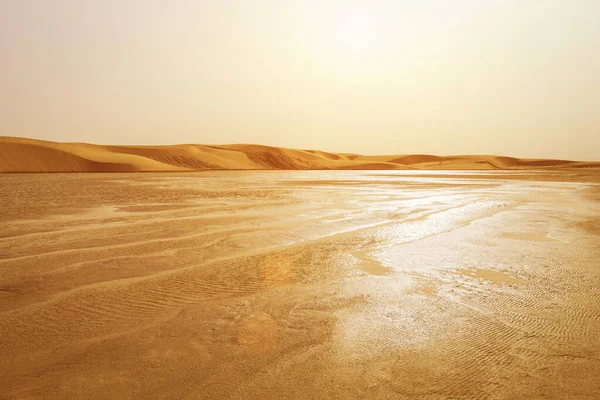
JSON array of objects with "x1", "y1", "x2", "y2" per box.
[{"x1": 0, "y1": 0, "x2": 600, "y2": 160}]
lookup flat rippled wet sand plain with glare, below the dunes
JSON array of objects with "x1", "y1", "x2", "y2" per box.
[{"x1": 0, "y1": 170, "x2": 600, "y2": 399}]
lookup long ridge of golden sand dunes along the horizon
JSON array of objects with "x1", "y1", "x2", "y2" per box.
[{"x1": 0, "y1": 137, "x2": 600, "y2": 172}]
